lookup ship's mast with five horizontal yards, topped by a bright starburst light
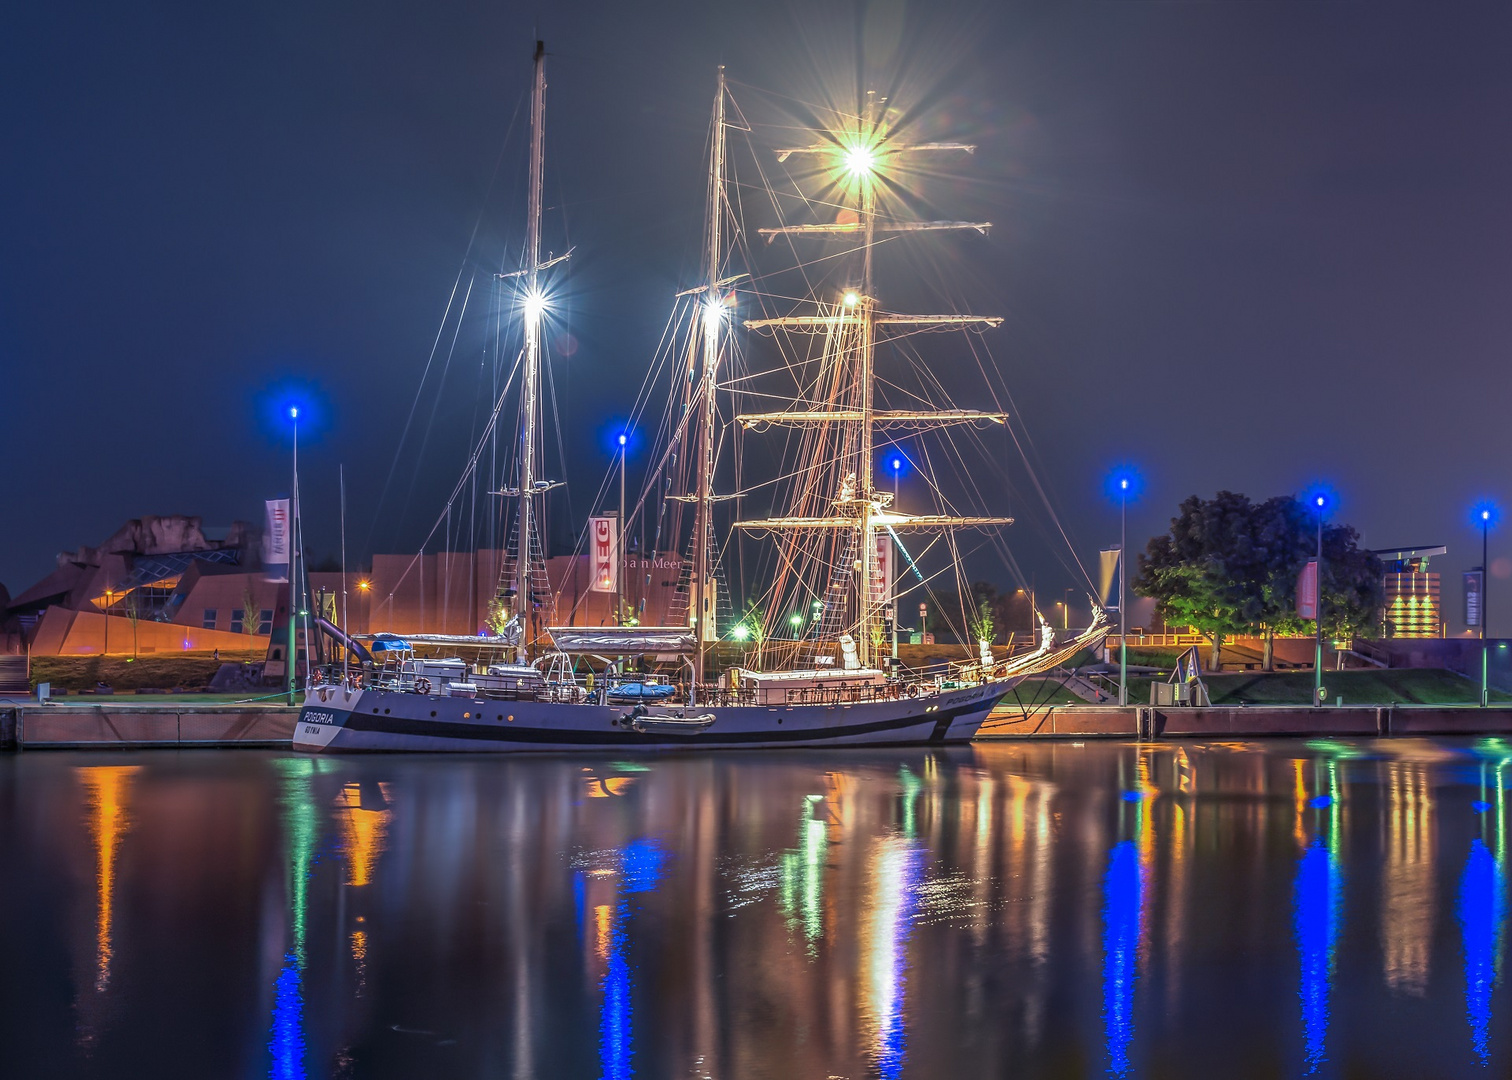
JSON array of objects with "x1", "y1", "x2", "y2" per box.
[{"x1": 735, "y1": 94, "x2": 1013, "y2": 667}]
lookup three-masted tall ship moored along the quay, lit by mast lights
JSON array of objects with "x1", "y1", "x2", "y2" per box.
[{"x1": 293, "y1": 42, "x2": 1108, "y2": 752}]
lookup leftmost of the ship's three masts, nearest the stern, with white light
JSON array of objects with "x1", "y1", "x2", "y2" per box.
[{"x1": 514, "y1": 41, "x2": 546, "y2": 664}]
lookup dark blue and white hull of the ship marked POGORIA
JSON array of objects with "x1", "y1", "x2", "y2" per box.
[{"x1": 293, "y1": 679, "x2": 1019, "y2": 753}]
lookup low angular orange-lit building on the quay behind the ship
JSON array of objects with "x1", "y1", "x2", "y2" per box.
[{"x1": 0, "y1": 516, "x2": 686, "y2": 655}]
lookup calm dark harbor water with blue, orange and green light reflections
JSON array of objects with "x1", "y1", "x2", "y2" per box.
[{"x1": 0, "y1": 738, "x2": 1512, "y2": 1080}]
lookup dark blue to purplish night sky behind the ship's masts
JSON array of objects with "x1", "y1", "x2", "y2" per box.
[{"x1": 0, "y1": 0, "x2": 1512, "y2": 634}]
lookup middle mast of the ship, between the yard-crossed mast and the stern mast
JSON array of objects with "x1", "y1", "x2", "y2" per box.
[{"x1": 692, "y1": 64, "x2": 724, "y2": 693}]
